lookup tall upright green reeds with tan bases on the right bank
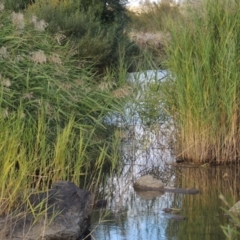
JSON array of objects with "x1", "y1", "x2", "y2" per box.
[{"x1": 165, "y1": 0, "x2": 240, "y2": 163}]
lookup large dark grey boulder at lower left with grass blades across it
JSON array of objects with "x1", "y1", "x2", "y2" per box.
[{"x1": 0, "y1": 181, "x2": 94, "y2": 240}]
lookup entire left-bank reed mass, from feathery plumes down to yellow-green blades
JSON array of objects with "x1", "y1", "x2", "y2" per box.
[{"x1": 0, "y1": 7, "x2": 124, "y2": 221}]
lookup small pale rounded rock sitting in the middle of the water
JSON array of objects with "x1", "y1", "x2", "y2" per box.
[{"x1": 134, "y1": 175, "x2": 164, "y2": 191}]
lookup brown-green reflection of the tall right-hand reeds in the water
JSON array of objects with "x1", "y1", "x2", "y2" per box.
[{"x1": 168, "y1": 167, "x2": 240, "y2": 240}]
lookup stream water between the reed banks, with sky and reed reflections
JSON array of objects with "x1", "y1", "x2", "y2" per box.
[{"x1": 91, "y1": 71, "x2": 240, "y2": 240}]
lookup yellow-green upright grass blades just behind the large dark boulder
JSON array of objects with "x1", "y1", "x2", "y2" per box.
[{"x1": 0, "y1": 110, "x2": 118, "y2": 215}]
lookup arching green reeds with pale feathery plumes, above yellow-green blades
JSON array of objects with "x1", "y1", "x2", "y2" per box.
[{"x1": 0, "y1": 10, "x2": 118, "y2": 129}]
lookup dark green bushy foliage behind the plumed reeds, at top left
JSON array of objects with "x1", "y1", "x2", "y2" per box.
[{"x1": 18, "y1": 0, "x2": 131, "y2": 69}]
